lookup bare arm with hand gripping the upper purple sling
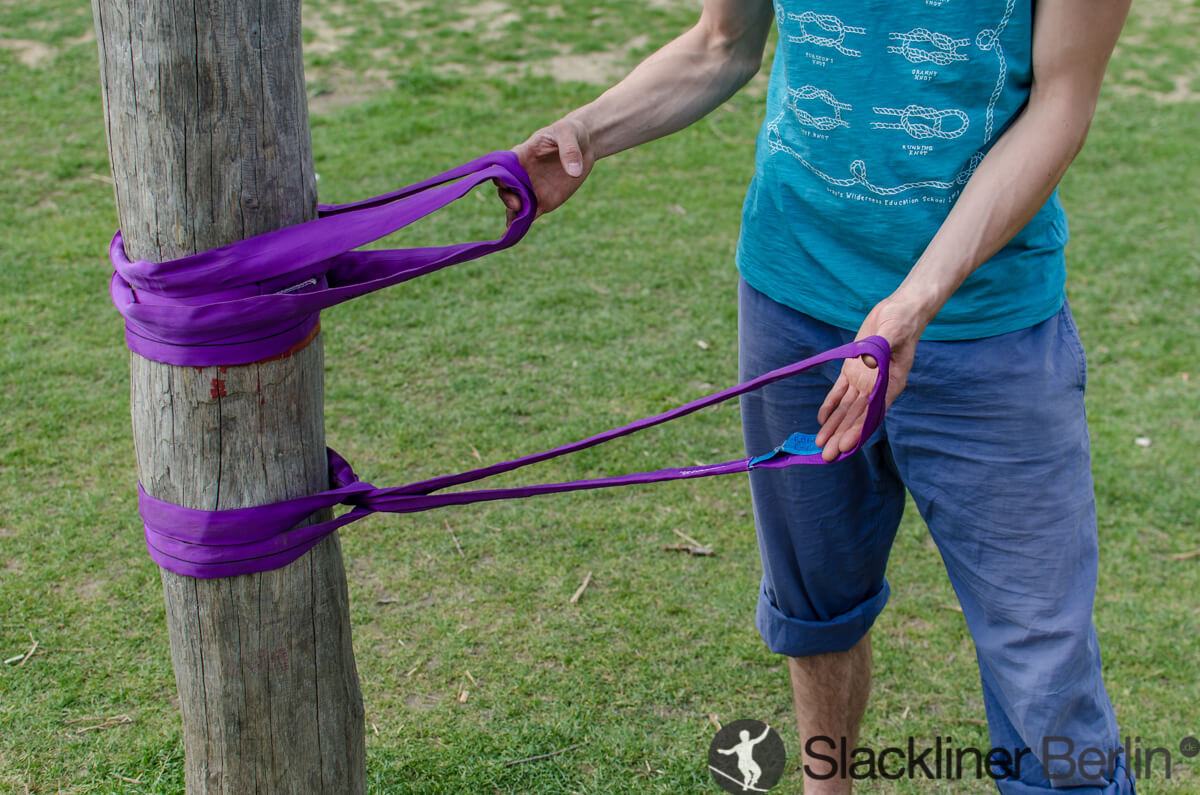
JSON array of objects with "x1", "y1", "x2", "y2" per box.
[{"x1": 500, "y1": 0, "x2": 774, "y2": 220}]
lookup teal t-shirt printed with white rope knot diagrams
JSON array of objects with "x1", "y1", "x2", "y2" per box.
[{"x1": 737, "y1": 0, "x2": 1067, "y2": 340}]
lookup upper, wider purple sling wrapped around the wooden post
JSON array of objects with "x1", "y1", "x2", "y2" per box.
[{"x1": 109, "y1": 151, "x2": 538, "y2": 366}]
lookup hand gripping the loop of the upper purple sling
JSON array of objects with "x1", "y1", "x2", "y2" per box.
[{"x1": 499, "y1": 116, "x2": 595, "y2": 223}]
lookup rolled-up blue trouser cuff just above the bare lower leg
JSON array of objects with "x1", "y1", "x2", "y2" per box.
[{"x1": 755, "y1": 579, "x2": 892, "y2": 657}]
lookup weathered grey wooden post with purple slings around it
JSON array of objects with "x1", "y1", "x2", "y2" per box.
[{"x1": 92, "y1": 0, "x2": 365, "y2": 795}]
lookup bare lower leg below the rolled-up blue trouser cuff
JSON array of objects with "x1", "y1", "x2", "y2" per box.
[{"x1": 787, "y1": 634, "x2": 871, "y2": 795}]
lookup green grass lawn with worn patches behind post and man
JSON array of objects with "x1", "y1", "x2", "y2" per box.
[{"x1": 0, "y1": 0, "x2": 1200, "y2": 794}]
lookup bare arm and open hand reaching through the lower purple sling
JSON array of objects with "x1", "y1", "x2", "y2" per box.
[{"x1": 816, "y1": 0, "x2": 1130, "y2": 461}]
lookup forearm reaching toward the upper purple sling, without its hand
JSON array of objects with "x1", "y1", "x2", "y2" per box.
[{"x1": 566, "y1": 0, "x2": 772, "y2": 157}]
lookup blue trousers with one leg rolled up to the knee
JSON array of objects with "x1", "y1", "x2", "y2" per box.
[{"x1": 738, "y1": 282, "x2": 1133, "y2": 794}]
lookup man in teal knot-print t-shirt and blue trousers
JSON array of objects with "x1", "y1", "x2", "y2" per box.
[{"x1": 504, "y1": 0, "x2": 1133, "y2": 793}]
